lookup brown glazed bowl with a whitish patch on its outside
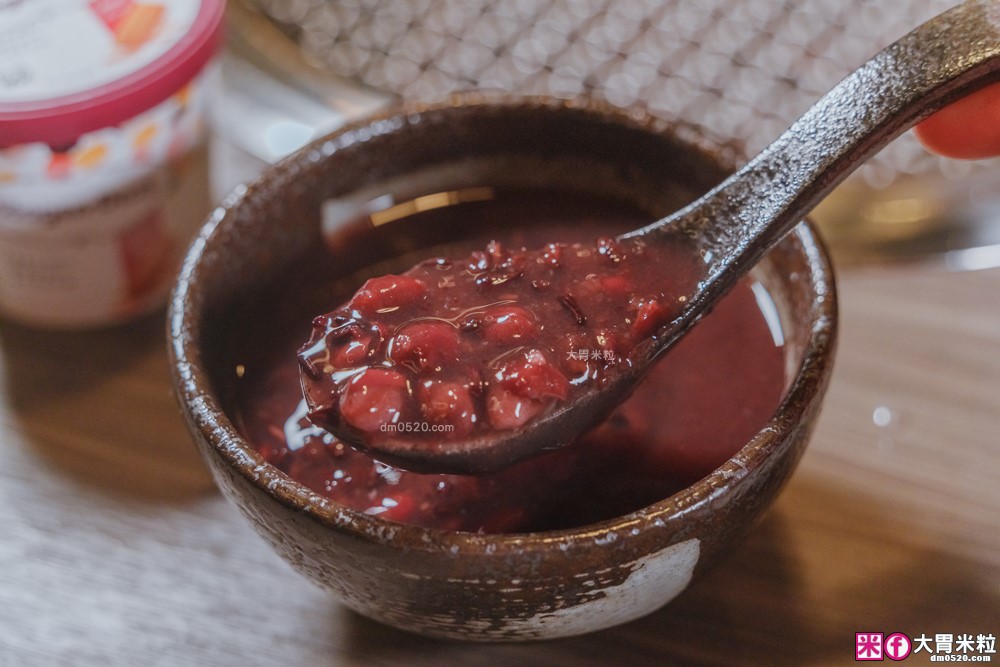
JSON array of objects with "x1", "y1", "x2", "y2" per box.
[{"x1": 169, "y1": 97, "x2": 836, "y2": 641}]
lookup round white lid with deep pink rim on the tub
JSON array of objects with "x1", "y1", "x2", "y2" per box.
[{"x1": 0, "y1": 0, "x2": 225, "y2": 147}]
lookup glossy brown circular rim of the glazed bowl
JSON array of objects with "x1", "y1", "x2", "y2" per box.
[{"x1": 167, "y1": 93, "x2": 838, "y2": 557}]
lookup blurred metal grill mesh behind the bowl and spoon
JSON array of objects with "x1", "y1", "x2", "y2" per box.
[{"x1": 255, "y1": 0, "x2": 981, "y2": 188}]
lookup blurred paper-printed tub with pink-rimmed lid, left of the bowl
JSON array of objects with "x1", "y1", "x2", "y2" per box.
[{"x1": 0, "y1": 0, "x2": 224, "y2": 328}]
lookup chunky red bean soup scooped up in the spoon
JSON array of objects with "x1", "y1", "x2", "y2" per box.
[{"x1": 299, "y1": 236, "x2": 704, "y2": 452}]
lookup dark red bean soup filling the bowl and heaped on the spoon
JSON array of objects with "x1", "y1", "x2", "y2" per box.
[{"x1": 230, "y1": 189, "x2": 785, "y2": 533}]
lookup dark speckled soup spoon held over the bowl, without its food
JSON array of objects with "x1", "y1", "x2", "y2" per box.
[{"x1": 302, "y1": 0, "x2": 1000, "y2": 473}]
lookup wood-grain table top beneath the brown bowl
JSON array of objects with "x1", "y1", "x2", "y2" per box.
[{"x1": 0, "y1": 197, "x2": 1000, "y2": 667}]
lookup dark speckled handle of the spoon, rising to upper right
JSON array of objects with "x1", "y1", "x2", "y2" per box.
[{"x1": 628, "y1": 0, "x2": 1000, "y2": 302}]
